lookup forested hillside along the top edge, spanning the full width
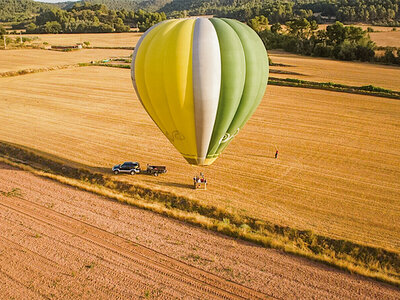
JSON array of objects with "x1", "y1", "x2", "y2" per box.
[{"x1": 0, "y1": 0, "x2": 400, "y2": 26}]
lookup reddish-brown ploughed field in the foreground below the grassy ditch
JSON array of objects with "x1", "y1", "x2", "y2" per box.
[{"x1": 0, "y1": 163, "x2": 400, "y2": 299}]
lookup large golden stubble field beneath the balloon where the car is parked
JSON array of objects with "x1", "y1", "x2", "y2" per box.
[{"x1": 0, "y1": 67, "x2": 400, "y2": 251}]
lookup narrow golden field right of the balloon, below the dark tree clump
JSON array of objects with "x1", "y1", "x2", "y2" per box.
[{"x1": 268, "y1": 51, "x2": 400, "y2": 91}]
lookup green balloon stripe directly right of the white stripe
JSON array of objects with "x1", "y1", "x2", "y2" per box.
[{"x1": 207, "y1": 18, "x2": 246, "y2": 158}]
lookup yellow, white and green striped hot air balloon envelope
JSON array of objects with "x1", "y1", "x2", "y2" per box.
[{"x1": 131, "y1": 18, "x2": 268, "y2": 166}]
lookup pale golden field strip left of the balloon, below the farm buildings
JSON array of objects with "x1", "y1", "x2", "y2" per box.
[{"x1": 0, "y1": 49, "x2": 132, "y2": 76}]
